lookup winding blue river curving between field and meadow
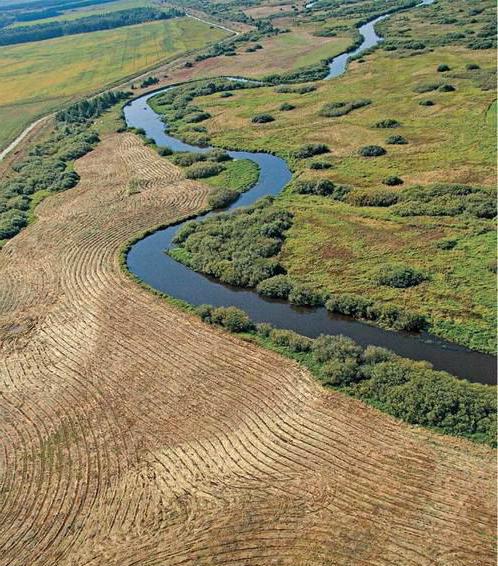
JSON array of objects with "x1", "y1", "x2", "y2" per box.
[{"x1": 124, "y1": 0, "x2": 496, "y2": 384}]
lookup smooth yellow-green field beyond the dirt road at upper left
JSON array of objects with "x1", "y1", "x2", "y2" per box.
[{"x1": 0, "y1": 18, "x2": 227, "y2": 151}]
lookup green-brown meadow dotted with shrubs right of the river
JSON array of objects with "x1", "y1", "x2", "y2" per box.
[{"x1": 159, "y1": 47, "x2": 496, "y2": 351}]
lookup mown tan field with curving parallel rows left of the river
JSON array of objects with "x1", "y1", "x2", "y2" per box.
[{"x1": 0, "y1": 133, "x2": 496, "y2": 566}]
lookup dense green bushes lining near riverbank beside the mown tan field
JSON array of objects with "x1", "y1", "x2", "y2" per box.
[{"x1": 196, "y1": 305, "x2": 497, "y2": 446}]
